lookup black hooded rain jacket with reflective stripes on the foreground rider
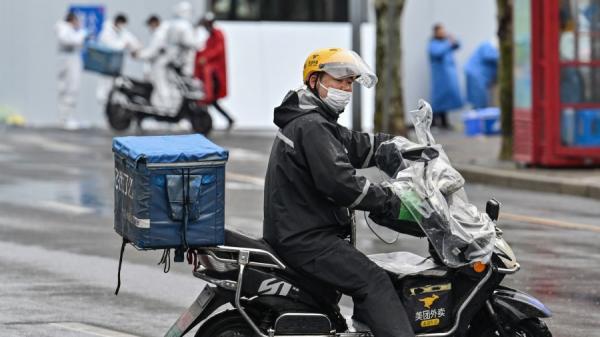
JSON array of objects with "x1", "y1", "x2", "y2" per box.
[{"x1": 263, "y1": 89, "x2": 400, "y2": 265}]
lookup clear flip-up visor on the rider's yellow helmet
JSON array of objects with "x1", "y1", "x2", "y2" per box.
[{"x1": 320, "y1": 51, "x2": 377, "y2": 88}]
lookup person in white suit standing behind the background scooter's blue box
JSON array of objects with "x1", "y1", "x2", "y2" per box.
[{"x1": 96, "y1": 14, "x2": 142, "y2": 104}]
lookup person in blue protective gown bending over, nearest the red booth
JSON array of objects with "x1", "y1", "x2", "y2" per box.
[{"x1": 465, "y1": 41, "x2": 498, "y2": 109}]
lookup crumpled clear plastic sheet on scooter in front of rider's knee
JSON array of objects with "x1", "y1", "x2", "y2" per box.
[{"x1": 368, "y1": 252, "x2": 448, "y2": 279}]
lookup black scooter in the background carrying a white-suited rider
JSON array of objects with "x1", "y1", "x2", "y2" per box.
[{"x1": 105, "y1": 64, "x2": 212, "y2": 135}]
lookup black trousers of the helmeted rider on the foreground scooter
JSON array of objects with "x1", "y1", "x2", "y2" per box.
[{"x1": 292, "y1": 239, "x2": 415, "y2": 337}]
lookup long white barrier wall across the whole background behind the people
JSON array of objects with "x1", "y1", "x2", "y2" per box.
[{"x1": 0, "y1": 0, "x2": 496, "y2": 129}]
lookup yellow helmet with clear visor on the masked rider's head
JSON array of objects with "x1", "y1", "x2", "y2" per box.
[{"x1": 302, "y1": 48, "x2": 377, "y2": 88}]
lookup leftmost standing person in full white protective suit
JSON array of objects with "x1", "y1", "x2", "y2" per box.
[{"x1": 55, "y1": 12, "x2": 87, "y2": 129}]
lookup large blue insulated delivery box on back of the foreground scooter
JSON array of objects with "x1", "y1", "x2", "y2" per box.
[{"x1": 113, "y1": 134, "x2": 228, "y2": 249}]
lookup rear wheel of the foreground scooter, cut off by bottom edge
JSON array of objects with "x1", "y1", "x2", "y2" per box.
[{"x1": 196, "y1": 310, "x2": 255, "y2": 337}]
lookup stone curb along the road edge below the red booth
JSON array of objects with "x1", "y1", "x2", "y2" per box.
[{"x1": 454, "y1": 165, "x2": 600, "y2": 200}]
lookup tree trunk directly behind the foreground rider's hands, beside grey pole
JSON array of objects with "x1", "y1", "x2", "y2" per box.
[{"x1": 374, "y1": 0, "x2": 406, "y2": 135}]
